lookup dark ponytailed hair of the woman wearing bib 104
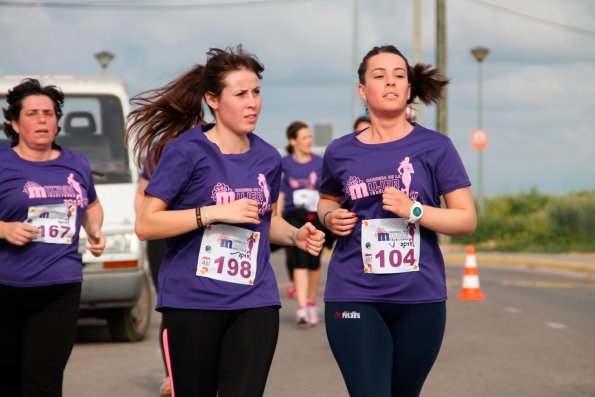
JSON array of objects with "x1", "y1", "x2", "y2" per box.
[{"x1": 357, "y1": 45, "x2": 450, "y2": 105}]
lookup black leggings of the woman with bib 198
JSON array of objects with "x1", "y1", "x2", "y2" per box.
[{"x1": 163, "y1": 306, "x2": 279, "y2": 397}]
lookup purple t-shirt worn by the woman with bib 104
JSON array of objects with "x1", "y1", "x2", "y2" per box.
[{"x1": 320, "y1": 124, "x2": 471, "y2": 303}]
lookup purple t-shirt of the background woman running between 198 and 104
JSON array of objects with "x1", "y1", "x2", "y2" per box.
[{"x1": 281, "y1": 154, "x2": 322, "y2": 215}]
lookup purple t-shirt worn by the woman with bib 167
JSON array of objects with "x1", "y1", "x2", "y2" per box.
[{"x1": 0, "y1": 145, "x2": 97, "y2": 287}]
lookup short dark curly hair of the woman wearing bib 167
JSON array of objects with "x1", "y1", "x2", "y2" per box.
[{"x1": 2, "y1": 78, "x2": 64, "y2": 146}]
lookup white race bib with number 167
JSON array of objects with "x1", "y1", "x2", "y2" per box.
[{"x1": 25, "y1": 204, "x2": 77, "y2": 244}]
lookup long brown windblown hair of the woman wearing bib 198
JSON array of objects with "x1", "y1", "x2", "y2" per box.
[{"x1": 124, "y1": 44, "x2": 264, "y2": 175}]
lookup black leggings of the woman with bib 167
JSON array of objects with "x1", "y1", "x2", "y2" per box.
[{"x1": 0, "y1": 283, "x2": 81, "y2": 397}]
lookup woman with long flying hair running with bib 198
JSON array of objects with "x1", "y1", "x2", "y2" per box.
[{"x1": 126, "y1": 46, "x2": 324, "y2": 397}]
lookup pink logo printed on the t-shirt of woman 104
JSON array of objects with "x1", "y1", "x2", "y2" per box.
[{"x1": 345, "y1": 156, "x2": 418, "y2": 200}]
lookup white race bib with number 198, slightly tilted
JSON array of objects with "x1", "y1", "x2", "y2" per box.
[{"x1": 196, "y1": 225, "x2": 260, "y2": 285}]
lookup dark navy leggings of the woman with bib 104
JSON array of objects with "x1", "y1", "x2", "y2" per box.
[{"x1": 325, "y1": 302, "x2": 446, "y2": 397}]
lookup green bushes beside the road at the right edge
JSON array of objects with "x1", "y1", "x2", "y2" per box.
[{"x1": 451, "y1": 189, "x2": 595, "y2": 252}]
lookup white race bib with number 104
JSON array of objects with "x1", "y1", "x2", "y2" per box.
[{"x1": 361, "y1": 218, "x2": 420, "y2": 274}]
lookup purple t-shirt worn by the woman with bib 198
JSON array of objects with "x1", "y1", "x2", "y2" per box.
[{"x1": 145, "y1": 125, "x2": 281, "y2": 310}]
